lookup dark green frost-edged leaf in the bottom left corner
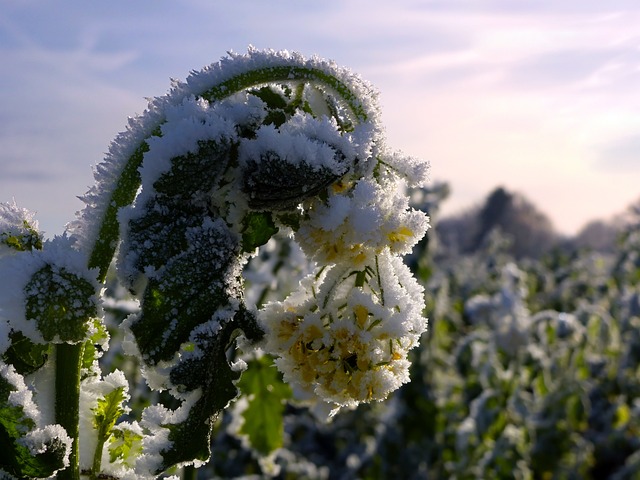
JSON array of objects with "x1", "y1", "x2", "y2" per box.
[{"x1": 0, "y1": 376, "x2": 67, "y2": 478}]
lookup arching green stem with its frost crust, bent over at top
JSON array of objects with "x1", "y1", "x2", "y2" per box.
[{"x1": 68, "y1": 48, "x2": 382, "y2": 274}]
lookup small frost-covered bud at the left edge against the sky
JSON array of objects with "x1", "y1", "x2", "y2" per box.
[{"x1": 0, "y1": 201, "x2": 42, "y2": 257}]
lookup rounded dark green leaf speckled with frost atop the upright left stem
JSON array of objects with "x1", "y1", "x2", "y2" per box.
[{"x1": 25, "y1": 265, "x2": 98, "y2": 342}]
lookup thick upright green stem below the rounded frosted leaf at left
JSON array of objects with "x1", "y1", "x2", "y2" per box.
[{"x1": 56, "y1": 342, "x2": 84, "y2": 480}]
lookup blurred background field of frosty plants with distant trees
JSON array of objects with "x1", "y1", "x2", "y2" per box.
[{"x1": 107, "y1": 184, "x2": 640, "y2": 480}]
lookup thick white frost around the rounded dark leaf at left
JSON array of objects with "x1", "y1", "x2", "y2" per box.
[{"x1": 0, "y1": 235, "x2": 100, "y2": 343}]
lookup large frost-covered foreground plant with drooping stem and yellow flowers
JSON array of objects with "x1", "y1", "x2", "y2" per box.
[{"x1": 0, "y1": 49, "x2": 428, "y2": 478}]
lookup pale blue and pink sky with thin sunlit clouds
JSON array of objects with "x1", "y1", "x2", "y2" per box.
[{"x1": 0, "y1": 0, "x2": 640, "y2": 237}]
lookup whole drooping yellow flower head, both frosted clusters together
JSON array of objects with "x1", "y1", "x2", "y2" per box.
[{"x1": 262, "y1": 153, "x2": 428, "y2": 413}]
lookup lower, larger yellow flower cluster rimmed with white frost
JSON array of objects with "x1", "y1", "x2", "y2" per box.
[{"x1": 263, "y1": 250, "x2": 427, "y2": 407}]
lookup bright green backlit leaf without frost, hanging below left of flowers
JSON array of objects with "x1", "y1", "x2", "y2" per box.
[{"x1": 238, "y1": 356, "x2": 292, "y2": 455}]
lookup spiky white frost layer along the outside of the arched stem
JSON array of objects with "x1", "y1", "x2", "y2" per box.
[{"x1": 68, "y1": 47, "x2": 382, "y2": 252}]
